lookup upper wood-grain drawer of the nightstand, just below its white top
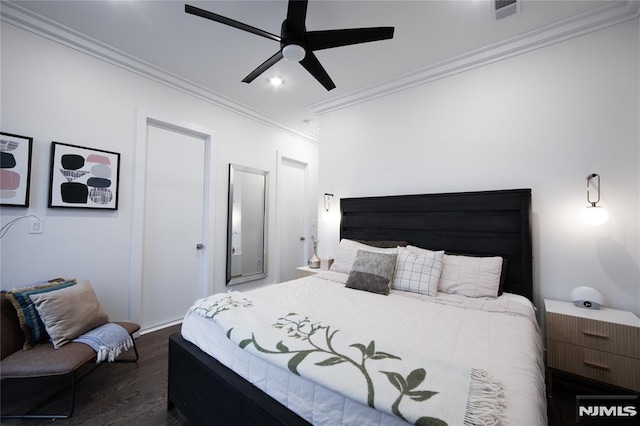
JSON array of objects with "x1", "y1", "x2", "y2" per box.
[{"x1": 546, "y1": 312, "x2": 640, "y2": 359}]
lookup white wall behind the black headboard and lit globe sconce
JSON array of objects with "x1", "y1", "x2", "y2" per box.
[{"x1": 319, "y1": 20, "x2": 640, "y2": 314}]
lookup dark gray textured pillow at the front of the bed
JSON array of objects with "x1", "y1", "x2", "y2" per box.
[{"x1": 346, "y1": 250, "x2": 398, "y2": 295}]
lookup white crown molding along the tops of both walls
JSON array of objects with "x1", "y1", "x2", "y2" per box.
[{"x1": 0, "y1": 0, "x2": 640, "y2": 133}]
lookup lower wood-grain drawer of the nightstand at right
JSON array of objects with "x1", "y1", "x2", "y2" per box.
[{"x1": 547, "y1": 340, "x2": 640, "y2": 392}]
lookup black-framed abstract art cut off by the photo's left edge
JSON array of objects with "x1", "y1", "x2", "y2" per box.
[{"x1": 0, "y1": 132, "x2": 33, "y2": 207}]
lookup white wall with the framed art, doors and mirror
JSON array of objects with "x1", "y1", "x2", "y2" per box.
[{"x1": 0, "y1": 22, "x2": 318, "y2": 320}]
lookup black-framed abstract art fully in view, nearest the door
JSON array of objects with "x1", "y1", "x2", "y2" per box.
[{"x1": 49, "y1": 142, "x2": 120, "y2": 210}]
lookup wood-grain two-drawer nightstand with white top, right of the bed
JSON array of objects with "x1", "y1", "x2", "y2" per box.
[{"x1": 544, "y1": 299, "x2": 640, "y2": 392}]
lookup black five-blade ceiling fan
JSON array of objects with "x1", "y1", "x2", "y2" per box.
[{"x1": 185, "y1": 0, "x2": 394, "y2": 90}]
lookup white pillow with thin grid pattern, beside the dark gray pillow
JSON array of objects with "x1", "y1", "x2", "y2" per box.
[{"x1": 393, "y1": 247, "x2": 444, "y2": 296}]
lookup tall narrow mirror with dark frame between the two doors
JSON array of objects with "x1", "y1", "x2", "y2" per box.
[{"x1": 227, "y1": 164, "x2": 269, "y2": 285}]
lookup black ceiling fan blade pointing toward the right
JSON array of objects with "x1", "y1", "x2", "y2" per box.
[{"x1": 306, "y1": 27, "x2": 394, "y2": 50}]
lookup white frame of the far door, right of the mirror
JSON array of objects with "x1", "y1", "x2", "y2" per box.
[{"x1": 274, "y1": 150, "x2": 310, "y2": 283}]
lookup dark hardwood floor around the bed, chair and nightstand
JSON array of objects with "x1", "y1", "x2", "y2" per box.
[{"x1": 0, "y1": 325, "x2": 636, "y2": 426}]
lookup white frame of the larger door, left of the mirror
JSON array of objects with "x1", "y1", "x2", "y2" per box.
[{"x1": 128, "y1": 111, "x2": 217, "y2": 334}]
